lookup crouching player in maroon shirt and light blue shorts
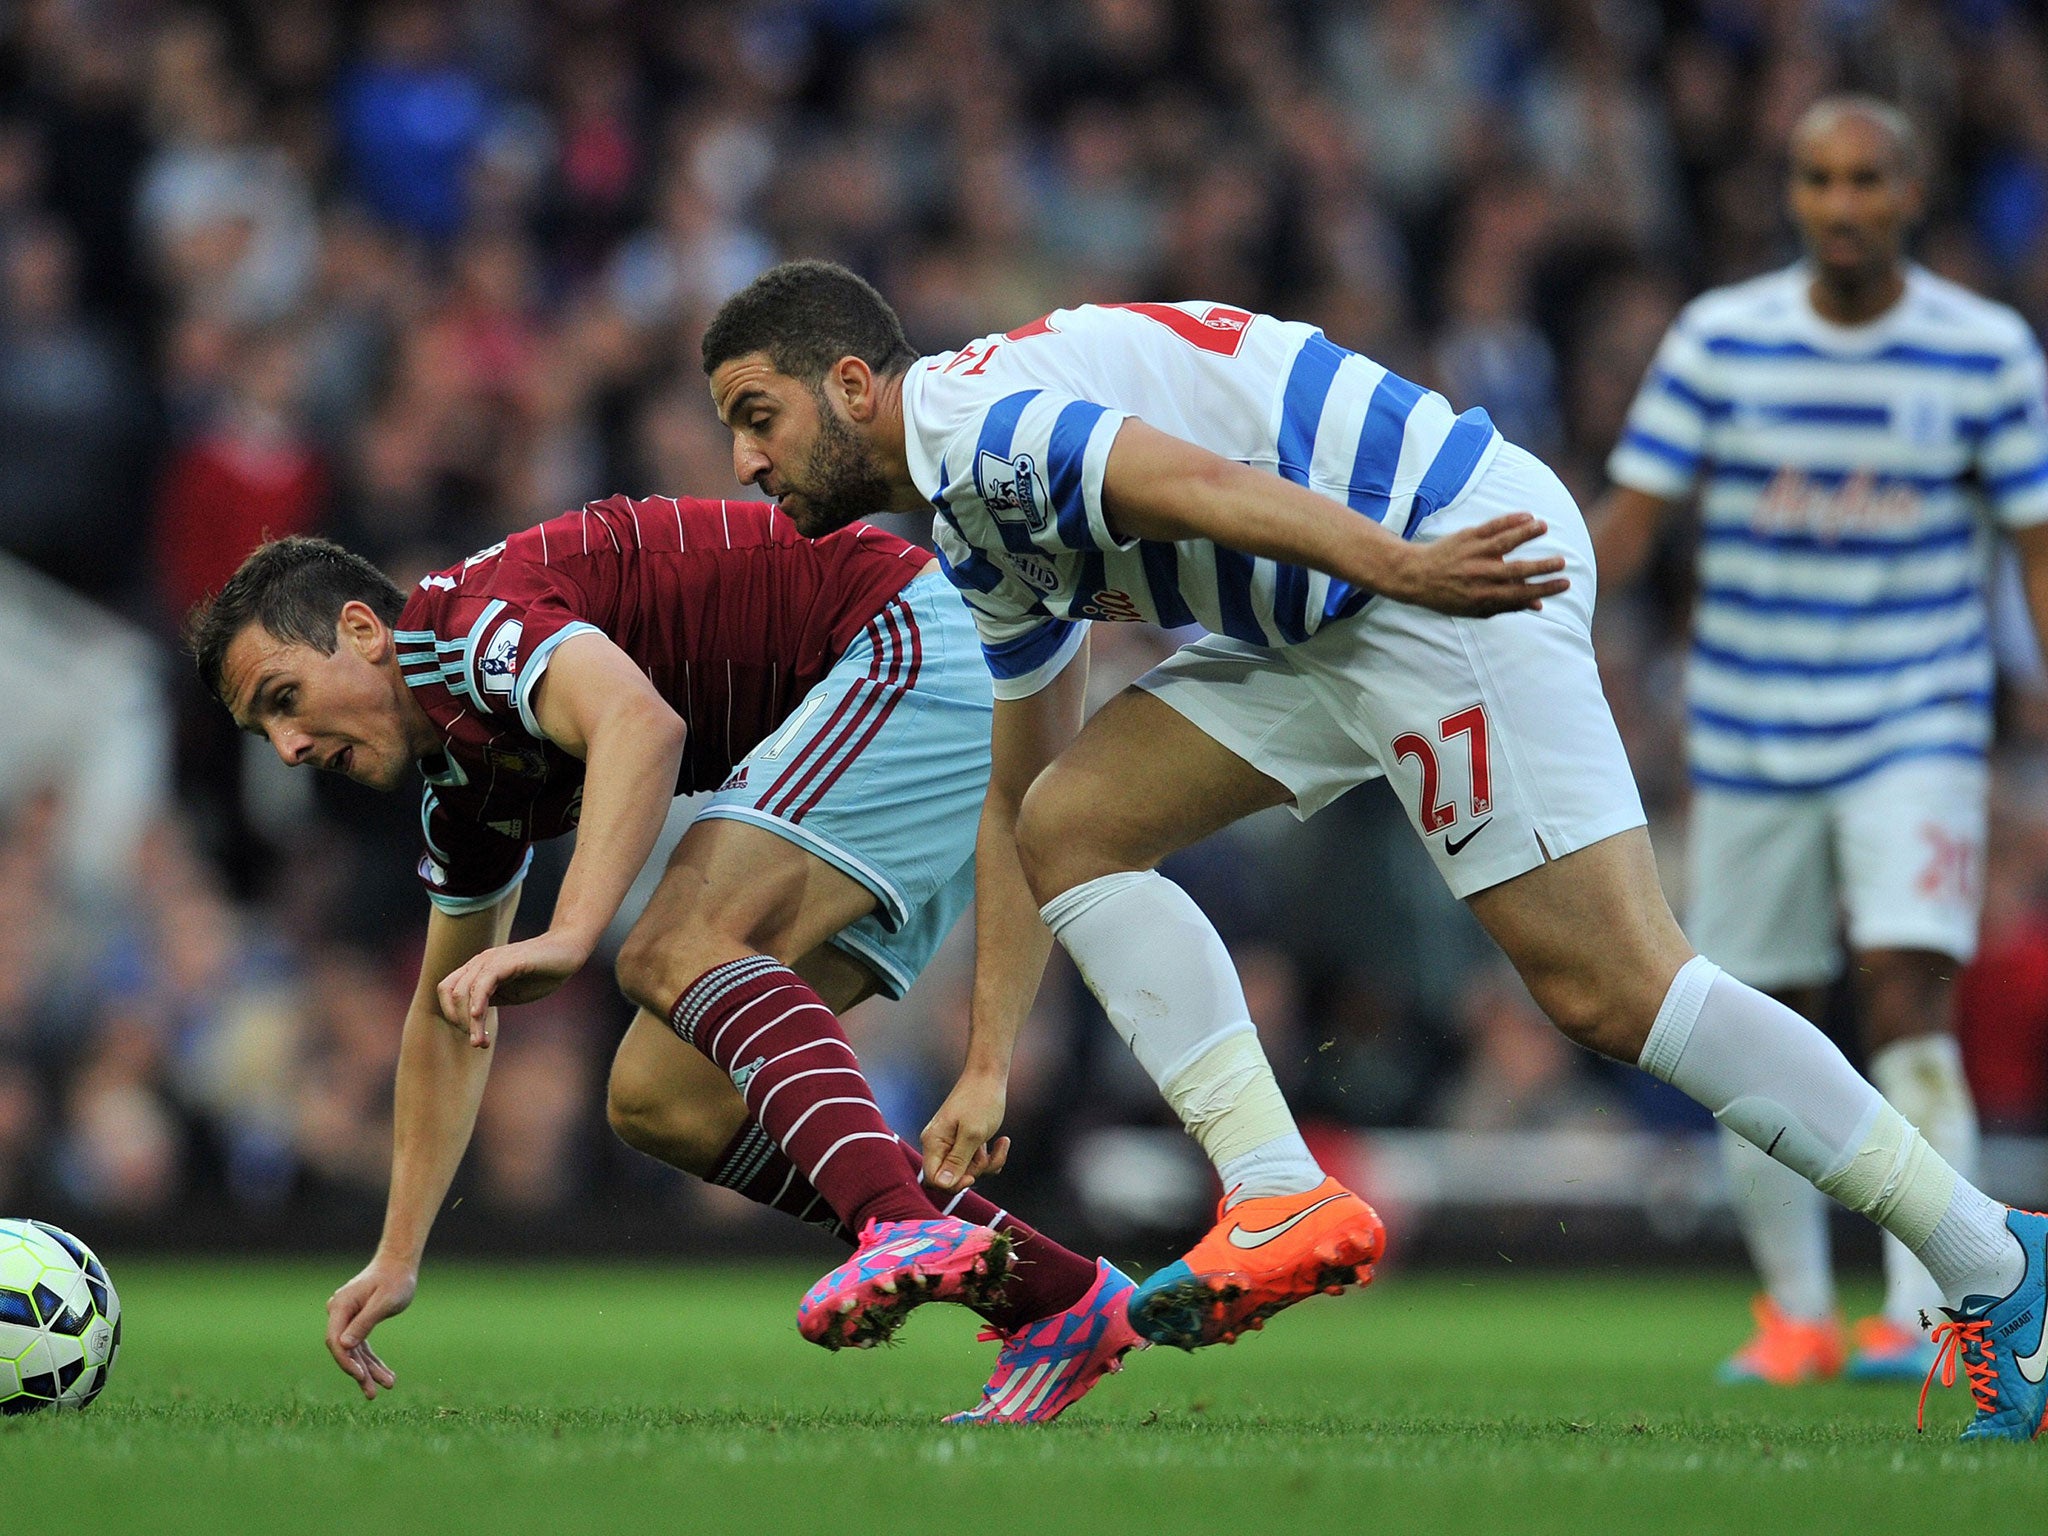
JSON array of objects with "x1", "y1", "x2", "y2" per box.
[{"x1": 190, "y1": 496, "x2": 1139, "y2": 1421}]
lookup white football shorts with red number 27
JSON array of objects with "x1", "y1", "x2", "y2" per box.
[{"x1": 1137, "y1": 442, "x2": 1642, "y2": 897}]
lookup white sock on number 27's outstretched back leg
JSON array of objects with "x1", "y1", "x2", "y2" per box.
[{"x1": 1636, "y1": 956, "x2": 2025, "y2": 1307}]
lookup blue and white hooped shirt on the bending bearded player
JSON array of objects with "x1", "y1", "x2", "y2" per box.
[{"x1": 903, "y1": 303, "x2": 1501, "y2": 698}]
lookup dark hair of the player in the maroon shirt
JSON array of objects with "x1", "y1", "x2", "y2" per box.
[{"x1": 184, "y1": 535, "x2": 406, "y2": 698}]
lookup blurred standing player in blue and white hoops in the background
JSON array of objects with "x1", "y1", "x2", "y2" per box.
[{"x1": 1595, "y1": 96, "x2": 2048, "y2": 1384}]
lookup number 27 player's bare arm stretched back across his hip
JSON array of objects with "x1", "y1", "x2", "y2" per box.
[{"x1": 1102, "y1": 418, "x2": 1571, "y2": 616}]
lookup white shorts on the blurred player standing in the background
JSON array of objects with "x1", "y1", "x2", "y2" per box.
[{"x1": 1686, "y1": 758, "x2": 1987, "y2": 989}]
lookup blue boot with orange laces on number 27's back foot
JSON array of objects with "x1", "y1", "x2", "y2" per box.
[{"x1": 1919, "y1": 1210, "x2": 2048, "y2": 1440}]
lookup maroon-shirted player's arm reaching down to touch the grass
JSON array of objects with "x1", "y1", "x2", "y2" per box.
[{"x1": 328, "y1": 889, "x2": 518, "y2": 1397}]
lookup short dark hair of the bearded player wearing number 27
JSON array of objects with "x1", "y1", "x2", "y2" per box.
[{"x1": 705, "y1": 262, "x2": 918, "y2": 389}]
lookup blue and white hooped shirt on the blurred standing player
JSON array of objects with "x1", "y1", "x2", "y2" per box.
[{"x1": 1608, "y1": 264, "x2": 2048, "y2": 793}]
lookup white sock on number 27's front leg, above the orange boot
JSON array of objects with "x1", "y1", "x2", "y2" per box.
[{"x1": 1040, "y1": 870, "x2": 1323, "y2": 1204}]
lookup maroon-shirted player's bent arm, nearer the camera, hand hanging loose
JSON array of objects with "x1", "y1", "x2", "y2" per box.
[{"x1": 440, "y1": 631, "x2": 686, "y2": 1032}]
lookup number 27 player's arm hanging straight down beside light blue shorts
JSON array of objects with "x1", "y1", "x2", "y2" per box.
[{"x1": 924, "y1": 639, "x2": 1087, "y2": 1190}]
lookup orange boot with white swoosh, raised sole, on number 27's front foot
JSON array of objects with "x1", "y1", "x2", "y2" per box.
[{"x1": 1130, "y1": 1180, "x2": 1386, "y2": 1350}]
